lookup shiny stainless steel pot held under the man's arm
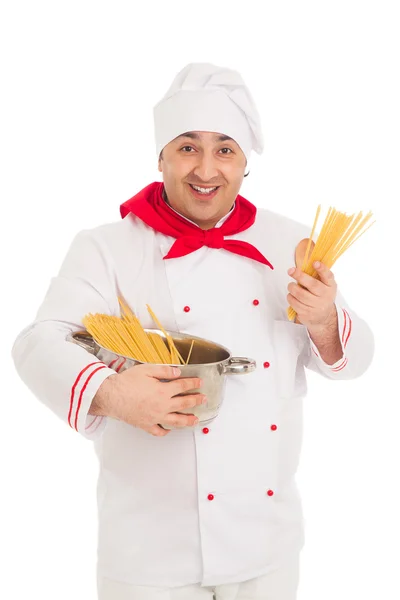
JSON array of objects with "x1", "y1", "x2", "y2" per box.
[{"x1": 67, "y1": 329, "x2": 256, "y2": 429}]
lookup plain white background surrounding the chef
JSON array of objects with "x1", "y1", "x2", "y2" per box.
[{"x1": 0, "y1": 0, "x2": 400, "y2": 600}]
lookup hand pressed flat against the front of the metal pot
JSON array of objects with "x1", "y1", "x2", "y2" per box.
[{"x1": 89, "y1": 364, "x2": 207, "y2": 436}]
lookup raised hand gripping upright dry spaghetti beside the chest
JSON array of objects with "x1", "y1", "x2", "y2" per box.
[{"x1": 287, "y1": 262, "x2": 337, "y2": 329}]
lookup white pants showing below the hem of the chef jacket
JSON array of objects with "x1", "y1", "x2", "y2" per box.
[{"x1": 98, "y1": 556, "x2": 299, "y2": 600}]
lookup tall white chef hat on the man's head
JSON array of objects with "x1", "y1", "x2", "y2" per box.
[{"x1": 154, "y1": 63, "x2": 264, "y2": 160}]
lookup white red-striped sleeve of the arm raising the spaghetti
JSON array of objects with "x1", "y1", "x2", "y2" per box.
[{"x1": 305, "y1": 291, "x2": 375, "y2": 379}]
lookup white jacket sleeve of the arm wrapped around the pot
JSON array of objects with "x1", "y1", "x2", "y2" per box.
[{"x1": 12, "y1": 231, "x2": 119, "y2": 439}]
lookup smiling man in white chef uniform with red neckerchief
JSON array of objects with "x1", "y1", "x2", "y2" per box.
[{"x1": 13, "y1": 63, "x2": 373, "y2": 600}]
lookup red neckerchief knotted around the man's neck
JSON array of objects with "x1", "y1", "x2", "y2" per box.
[{"x1": 120, "y1": 181, "x2": 274, "y2": 269}]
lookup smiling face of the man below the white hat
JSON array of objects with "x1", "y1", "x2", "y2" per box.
[{"x1": 158, "y1": 131, "x2": 247, "y2": 229}]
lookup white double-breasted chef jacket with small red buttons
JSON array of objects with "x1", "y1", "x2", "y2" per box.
[{"x1": 13, "y1": 202, "x2": 374, "y2": 587}]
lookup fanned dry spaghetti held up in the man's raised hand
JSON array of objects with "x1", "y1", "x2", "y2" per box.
[{"x1": 287, "y1": 205, "x2": 375, "y2": 321}]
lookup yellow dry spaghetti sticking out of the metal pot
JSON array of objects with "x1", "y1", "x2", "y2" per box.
[{"x1": 83, "y1": 298, "x2": 194, "y2": 365}]
